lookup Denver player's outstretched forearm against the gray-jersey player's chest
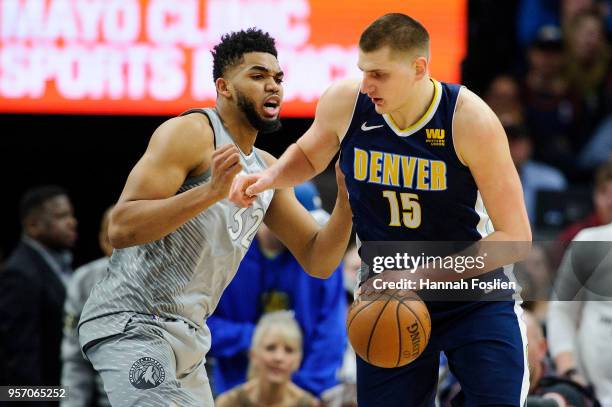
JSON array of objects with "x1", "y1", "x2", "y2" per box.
[{"x1": 265, "y1": 143, "x2": 322, "y2": 189}]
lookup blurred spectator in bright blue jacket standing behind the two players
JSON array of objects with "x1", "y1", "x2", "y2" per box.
[{"x1": 208, "y1": 183, "x2": 346, "y2": 396}]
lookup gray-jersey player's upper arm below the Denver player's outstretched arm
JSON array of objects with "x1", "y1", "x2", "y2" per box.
[{"x1": 264, "y1": 188, "x2": 319, "y2": 266}]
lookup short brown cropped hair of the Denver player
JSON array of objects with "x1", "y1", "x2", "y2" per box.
[{"x1": 359, "y1": 13, "x2": 429, "y2": 58}]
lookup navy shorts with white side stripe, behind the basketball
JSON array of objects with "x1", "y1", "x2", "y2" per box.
[{"x1": 357, "y1": 301, "x2": 529, "y2": 407}]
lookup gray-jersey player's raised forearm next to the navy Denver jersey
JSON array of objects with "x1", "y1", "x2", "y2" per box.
[{"x1": 305, "y1": 196, "x2": 353, "y2": 278}]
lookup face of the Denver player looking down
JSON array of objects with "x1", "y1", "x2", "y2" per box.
[{"x1": 357, "y1": 47, "x2": 422, "y2": 114}]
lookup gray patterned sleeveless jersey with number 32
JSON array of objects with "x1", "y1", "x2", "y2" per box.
[{"x1": 79, "y1": 109, "x2": 273, "y2": 344}]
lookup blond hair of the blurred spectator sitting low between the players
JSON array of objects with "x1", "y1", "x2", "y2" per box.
[{"x1": 247, "y1": 311, "x2": 302, "y2": 379}]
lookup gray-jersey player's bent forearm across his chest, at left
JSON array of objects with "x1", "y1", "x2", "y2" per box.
[{"x1": 108, "y1": 183, "x2": 223, "y2": 249}]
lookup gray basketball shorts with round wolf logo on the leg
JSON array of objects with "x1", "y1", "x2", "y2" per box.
[{"x1": 81, "y1": 314, "x2": 214, "y2": 407}]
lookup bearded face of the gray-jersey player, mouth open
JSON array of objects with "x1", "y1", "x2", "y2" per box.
[{"x1": 229, "y1": 52, "x2": 283, "y2": 133}]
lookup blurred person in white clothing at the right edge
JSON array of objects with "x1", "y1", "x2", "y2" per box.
[{"x1": 548, "y1": 223, "x2": 612, "y2": 406}]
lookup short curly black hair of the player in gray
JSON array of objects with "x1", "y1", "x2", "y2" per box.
[{"x1": 211, "y1": 28, "x2": 278, "y2": 81}]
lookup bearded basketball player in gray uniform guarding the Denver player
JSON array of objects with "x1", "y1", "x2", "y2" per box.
[{"x1": 78, "y1": 29, "x2": 351, "y2": 406}]
